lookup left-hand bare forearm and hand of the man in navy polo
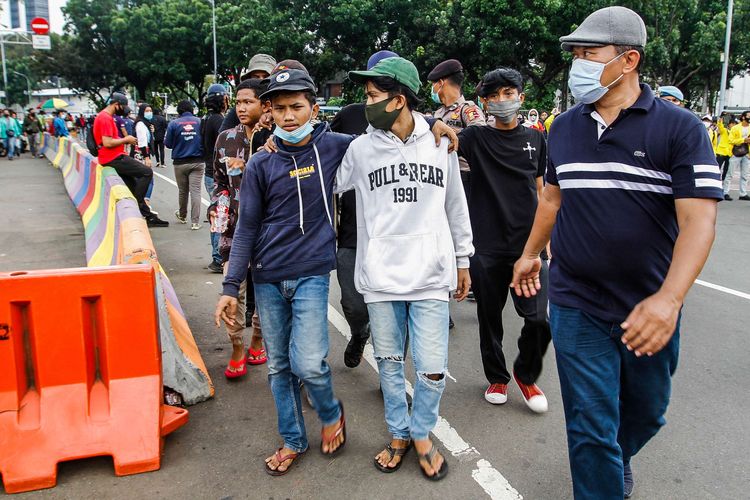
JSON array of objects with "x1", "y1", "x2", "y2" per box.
[{"x1": 510, "y1": 184, "x2": 562, "y2": 297}]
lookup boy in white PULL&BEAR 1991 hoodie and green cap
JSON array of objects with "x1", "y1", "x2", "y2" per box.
[{"x1": 336, "y1": 57, "x2": 474, "y2": 480}]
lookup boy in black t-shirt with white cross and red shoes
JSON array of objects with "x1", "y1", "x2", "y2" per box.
[{"x1": 459, "y1": 68, "x2": 550, "y2": 413}]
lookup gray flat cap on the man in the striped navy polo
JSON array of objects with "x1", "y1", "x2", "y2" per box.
[{"x1": 560, "y1": 6, "x2": 646, "y2": 51}]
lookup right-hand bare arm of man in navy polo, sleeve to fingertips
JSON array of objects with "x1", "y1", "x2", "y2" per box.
[{"x1": 620, "y1": 198, "x2": 717, "y2": 356}]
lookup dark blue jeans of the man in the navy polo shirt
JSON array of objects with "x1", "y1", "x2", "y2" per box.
[{"x1": 550, "y1": 304, "x2": 680, "y2": 500}]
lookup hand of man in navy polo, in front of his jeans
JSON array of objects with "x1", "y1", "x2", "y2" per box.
[{"x1": 620, "y1": 292, "x2": 682, "y2": 357}]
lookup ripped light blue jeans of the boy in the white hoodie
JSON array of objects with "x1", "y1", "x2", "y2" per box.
[{"x1": 367, "y1": 300, "x2": 449, "y2": 439}]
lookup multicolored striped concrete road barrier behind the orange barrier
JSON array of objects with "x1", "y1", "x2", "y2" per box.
[{"x1": 41, "y1": 134, "x2": 214, "y2": 405}]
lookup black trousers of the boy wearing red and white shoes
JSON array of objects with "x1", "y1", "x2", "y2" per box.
[{"x1": 476, "y1": 254, "x2": 551, "y2": 384}]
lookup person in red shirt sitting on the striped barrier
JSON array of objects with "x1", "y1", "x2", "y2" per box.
[{"x1": 94, "y1": 92, "x2": 169, "y2": 227}]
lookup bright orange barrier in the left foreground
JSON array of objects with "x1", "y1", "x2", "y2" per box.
[{"x1": 0, "y1": 265, "x2": 188, "y2": 493}]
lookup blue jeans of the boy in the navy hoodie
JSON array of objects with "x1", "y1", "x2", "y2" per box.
[{"x1": 255, "y1": 275, "x2": 341, "y2": 452}]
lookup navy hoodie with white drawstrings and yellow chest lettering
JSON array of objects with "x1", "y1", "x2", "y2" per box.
[{"x1": 223, "y1": 123, "x2": 353, "y2": 297}]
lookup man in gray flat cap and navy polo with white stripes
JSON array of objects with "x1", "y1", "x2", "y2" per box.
[{"x1": 511, "y1": 7, "x2": 722, "y2": 500}]
